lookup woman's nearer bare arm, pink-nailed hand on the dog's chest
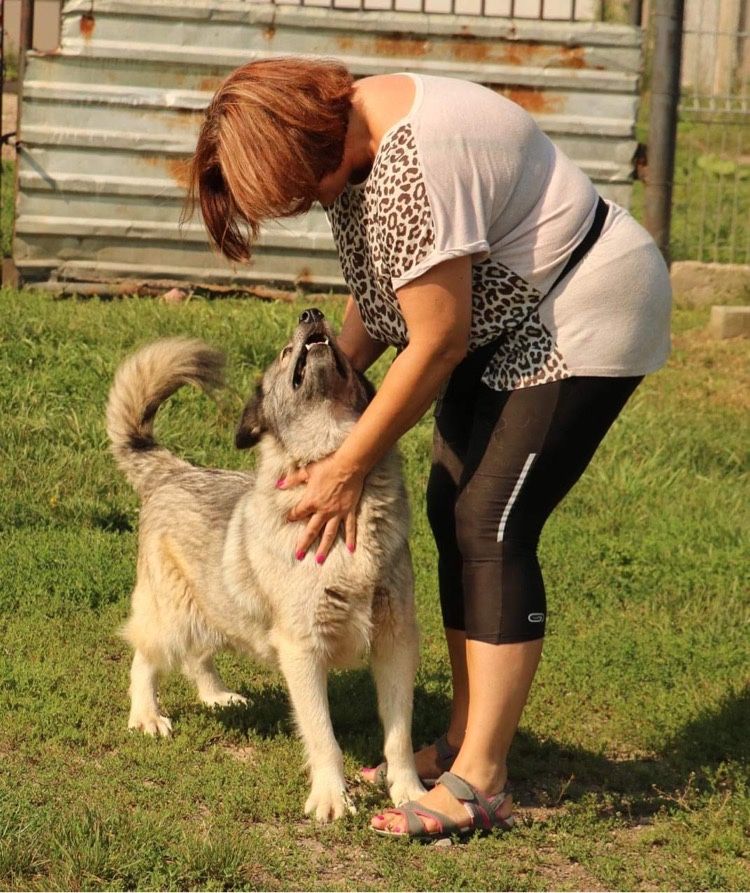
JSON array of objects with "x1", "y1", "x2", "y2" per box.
[{"x1": 288, "y1": 257, "x2": 471, "y2": 561}]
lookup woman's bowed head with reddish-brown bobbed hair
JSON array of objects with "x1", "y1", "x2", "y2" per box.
[{"x1": 188, "y1": 58, "x2": 353, "y2": 260}]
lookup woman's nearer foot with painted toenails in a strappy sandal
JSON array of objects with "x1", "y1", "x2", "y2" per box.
[{"x1": 370, "y1": 773, "x2": 513, "y2": 837}]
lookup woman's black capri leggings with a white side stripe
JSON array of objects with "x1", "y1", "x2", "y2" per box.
[{"x1": 427, "y1": 377, "x2": 641, "y2": 644}]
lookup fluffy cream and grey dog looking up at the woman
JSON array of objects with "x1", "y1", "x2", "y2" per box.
[{"x1": 107, "y1": 309, "x2": 424, "y2": 822}]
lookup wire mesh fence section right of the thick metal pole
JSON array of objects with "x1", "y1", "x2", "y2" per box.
[{"x1": 671, "y1": 0, "x2": 750, "y2": 263}]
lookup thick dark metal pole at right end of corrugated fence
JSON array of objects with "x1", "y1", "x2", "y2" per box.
[{"x1": 645, "y1": 0, "x2": 685, "y2": 263}]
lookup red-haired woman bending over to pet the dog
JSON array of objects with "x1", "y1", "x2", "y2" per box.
[{"x1": 192, "y1": 59, "x2": 670, "y2": 837}]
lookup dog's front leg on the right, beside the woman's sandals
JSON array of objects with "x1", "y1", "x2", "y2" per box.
[{"x1": 372, "y1": 619, "x2": 424, "y2": 806}]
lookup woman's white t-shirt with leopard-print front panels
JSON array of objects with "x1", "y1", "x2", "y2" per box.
[{"x1": 326, "y1": 75, "x2": 671, "y2": 390}]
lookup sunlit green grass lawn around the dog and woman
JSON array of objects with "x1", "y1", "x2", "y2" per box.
[{"x1": 0, "y1": 289, "x2": 750, "y2": 890}]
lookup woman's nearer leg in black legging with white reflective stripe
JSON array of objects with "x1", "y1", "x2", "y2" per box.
[{"x1": 373, "y1": 378, "x2": 639, "y2": 831}]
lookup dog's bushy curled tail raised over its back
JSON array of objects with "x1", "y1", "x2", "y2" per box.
[{"x1": 107, "y1": 338, "x2": 224, "y2": 493}]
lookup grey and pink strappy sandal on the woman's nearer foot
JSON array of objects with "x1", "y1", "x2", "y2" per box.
[{"x1": 372, "y1": 772, "x2": 515, "y2": 840}]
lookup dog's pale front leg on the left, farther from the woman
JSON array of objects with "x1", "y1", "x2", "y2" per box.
[{"x1": 278, "y1": 642, "x2": 354, "y2": 822}]
